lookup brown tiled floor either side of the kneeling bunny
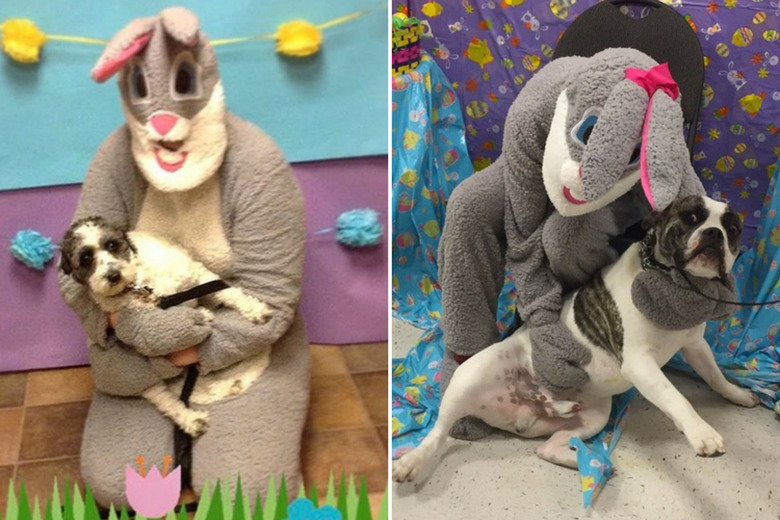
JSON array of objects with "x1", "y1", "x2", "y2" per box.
[{"x1": 0, "y1": 343, "x2": 388, "y2": 516}]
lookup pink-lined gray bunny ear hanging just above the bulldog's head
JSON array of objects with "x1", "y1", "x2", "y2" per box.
[{"x1": 640, "y1": 90, "x2": 704, "y2": 211}]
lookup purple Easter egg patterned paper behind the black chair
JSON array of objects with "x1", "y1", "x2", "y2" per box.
[{"x1": 393, "y1": 0, "x2": 780, "y2": 248}]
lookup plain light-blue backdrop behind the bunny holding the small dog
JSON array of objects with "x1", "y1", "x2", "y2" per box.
[{"x1": 0, "y1": 0, "x2": 389, "y2": 189}]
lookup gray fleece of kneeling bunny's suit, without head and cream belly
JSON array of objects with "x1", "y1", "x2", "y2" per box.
[{"x1": 59, "y1": 114, "x2": 310, "y2": 505}]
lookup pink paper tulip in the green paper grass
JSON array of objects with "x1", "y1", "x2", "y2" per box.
[{"x1": 125, "y1": 457, "x2": 181, "y2": 518}]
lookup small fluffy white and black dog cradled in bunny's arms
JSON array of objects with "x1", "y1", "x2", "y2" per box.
[{"x1": 60, "y1": 217, "x2": 271, "y2": 436}]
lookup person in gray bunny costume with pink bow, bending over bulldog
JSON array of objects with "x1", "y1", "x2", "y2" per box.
[{"x1": 439, "y1": 49, "x2": 734, "y2": 440}]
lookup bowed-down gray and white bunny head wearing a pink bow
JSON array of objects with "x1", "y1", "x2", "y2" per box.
[{"x1": 542, "y1": 49, "x2": 700, "y2": 216}]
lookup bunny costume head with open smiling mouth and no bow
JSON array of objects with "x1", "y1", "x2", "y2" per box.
[{"x1": 92, "y1": 7, "x2": 227, "y2": 192}]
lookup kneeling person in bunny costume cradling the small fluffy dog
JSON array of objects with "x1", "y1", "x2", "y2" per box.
[{"x1": 60, "y1": 8, "x2": 310, "y2": 506}]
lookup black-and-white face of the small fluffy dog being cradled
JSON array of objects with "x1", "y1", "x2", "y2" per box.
[{"x1": 60, "y1": 217, "x2": 136, "y2": 297}]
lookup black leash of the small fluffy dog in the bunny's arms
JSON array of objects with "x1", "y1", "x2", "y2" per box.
[{"x1": 157, "y1": 280, "x2": 230, "y2": 488}]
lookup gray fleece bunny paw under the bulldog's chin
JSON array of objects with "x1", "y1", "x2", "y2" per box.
[{"x1": 631, "y1": 269, "x2": 738, "y2": 330}]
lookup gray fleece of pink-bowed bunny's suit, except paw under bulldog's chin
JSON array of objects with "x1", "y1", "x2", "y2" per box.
[{"x1": 439, "y1": 49, "x2": 704, "y2": 410}]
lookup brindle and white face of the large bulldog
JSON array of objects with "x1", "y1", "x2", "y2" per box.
[{"x1": 652, "y1": 196, "x2": 742, "y2": 279}]
